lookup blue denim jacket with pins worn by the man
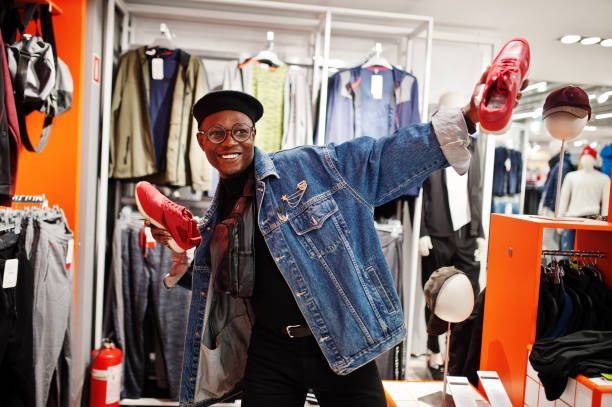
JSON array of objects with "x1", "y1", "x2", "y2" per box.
[{"x1": 180, "y1": 110, "x2": 470, "y2": 406}]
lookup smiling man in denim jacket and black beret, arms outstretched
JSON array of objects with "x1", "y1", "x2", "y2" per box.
[{"x1": 147, "y1": 68, "x2": 526, "y2": 407}]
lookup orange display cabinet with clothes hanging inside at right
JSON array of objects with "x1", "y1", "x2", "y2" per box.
[{"x1": 480, "y1": 215, "x2": 612, "y2": 407}]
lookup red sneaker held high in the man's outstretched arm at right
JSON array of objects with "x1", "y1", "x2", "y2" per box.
[{"x1": 478, "y1": 38, "x2": 530, "y2": 134}]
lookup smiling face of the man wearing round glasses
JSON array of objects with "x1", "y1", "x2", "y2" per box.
[{"x1": 198, "y1": 110, "x2": 255, "y2": 178}]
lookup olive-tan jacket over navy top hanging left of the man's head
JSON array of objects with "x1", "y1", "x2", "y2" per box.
[{"x1": 109, "y1": 47, "x2": 212, "y2": 191}]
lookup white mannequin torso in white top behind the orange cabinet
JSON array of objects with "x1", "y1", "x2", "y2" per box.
[{"x1": 559, "y1": 154, "x2": 610, "y2": 216}]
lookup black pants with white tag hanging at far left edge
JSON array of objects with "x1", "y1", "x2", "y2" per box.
[{"x1": 0, "y1": 232, "x2": 35, "y2": 407}]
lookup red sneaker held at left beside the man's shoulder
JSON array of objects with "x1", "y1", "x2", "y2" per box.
[{"x1": 134, "y1": 181, "x2": 202, "y2": 253}]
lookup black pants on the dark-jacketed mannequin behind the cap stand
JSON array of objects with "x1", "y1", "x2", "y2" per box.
[{"x1": 421, "y1": 223, "x2": 480, "y2": 353}]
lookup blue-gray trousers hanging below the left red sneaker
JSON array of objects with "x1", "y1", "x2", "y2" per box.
[{"x1": 121, "y1": 227, "x2": 191, "y2": 399}]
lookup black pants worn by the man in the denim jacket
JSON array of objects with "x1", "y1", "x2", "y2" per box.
[{"x1": 242, "y1": 324, "x2": 387, "y2": 407}]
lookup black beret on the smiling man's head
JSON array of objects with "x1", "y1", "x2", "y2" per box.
[{"x1": 193, "y1": 90, "x2": 263, "y2": 126}]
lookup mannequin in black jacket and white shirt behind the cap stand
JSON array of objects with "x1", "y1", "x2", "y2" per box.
[{"x1": 419, "y1": 92, "x2": 486, "y2": 380}]
